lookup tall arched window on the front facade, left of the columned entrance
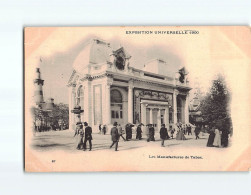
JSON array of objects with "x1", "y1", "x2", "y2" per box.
[{"x1": 111, "y1": 89, "x2": 123, "y2": 119}]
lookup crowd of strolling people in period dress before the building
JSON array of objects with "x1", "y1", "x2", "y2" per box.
[{"x1": 74, "y1": 122, "x2": 229, "y2": 151}]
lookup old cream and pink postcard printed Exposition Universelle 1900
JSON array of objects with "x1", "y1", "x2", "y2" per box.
[{"x1": 24, "y1": 26, "x2": 251, "y2": 172}]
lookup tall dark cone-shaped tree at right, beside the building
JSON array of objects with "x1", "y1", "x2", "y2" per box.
[{"x1": 200, "y1": 74, "x2": 232, "y2": 131}]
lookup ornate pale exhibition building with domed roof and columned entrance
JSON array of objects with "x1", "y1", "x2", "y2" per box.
[{"x1": 68, "y1": 39, "x2": 191, "y2": 130}]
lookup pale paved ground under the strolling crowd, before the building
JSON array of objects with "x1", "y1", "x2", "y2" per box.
[{"x1": 32, "y1": 130, "x2": 212, "y2": 151}]
